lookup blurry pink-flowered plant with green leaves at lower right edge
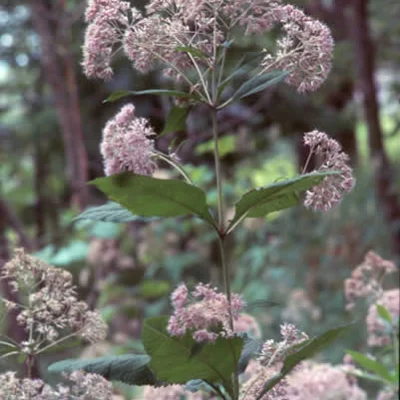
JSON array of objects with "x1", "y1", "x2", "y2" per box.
[{"x1": 344, "y1": 251, "x2": 400, "y2": 400}]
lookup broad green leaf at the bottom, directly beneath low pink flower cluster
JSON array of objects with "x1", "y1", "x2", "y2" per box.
[{"x1": 142, "y1": 317, "x2": 243, "y2": 392}]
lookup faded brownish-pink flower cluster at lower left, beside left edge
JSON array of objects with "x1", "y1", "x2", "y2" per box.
[{"x1": 0, "y1": 249, "x2": 107, "y2": 355}]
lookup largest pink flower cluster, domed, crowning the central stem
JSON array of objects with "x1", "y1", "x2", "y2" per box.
[{"x1": 83, "y1": 0, "x2": 333, "y2": 92}]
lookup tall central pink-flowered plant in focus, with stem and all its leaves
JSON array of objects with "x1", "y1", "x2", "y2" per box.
[{"x1": 0, "y1": 0, "x2": 376, "y2": 400}]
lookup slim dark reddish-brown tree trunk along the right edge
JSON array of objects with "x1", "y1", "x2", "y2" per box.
[{"x1": 351, "y1": 0, "x2": 400, "y2": 257}]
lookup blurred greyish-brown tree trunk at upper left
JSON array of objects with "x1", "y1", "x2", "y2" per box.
[{"x1": 27, "y1": 0, "x2": 88, "y2": 209}]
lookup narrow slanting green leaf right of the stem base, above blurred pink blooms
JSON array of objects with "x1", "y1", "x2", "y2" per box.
[{"x1": 256, "y1": 324, "x2": 353, "y2": 400}]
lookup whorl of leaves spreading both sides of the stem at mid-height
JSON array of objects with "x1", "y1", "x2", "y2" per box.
[{"x1": 77, "y1": 172, "x2": 332, "y2": 233}]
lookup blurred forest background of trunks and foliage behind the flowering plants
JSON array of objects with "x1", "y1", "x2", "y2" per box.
[{"x1": 0, "y1": 0, "x2": 400, "y2": 398}]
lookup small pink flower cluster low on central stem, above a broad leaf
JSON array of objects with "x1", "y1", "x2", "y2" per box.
[{"x1": 168, "y1": 283, "x2": 245, "y2": 343}]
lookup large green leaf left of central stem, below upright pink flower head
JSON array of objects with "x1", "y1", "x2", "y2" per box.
[{"x1": 90, "y1": 172, "x2": 215, "y2": 226}]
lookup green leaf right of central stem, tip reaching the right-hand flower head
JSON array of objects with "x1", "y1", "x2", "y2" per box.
[{"x1": 228, "y1": 172, "x2": 336, "y2": 231}]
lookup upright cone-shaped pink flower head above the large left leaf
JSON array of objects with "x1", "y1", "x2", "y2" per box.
[{"x1": 100, "y1": 104, "x2": 156, "y2": 175}]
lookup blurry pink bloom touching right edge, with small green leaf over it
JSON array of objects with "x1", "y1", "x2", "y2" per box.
[{"x1": 366, "y1": 289, "x2": 400, "y2": 347}]
